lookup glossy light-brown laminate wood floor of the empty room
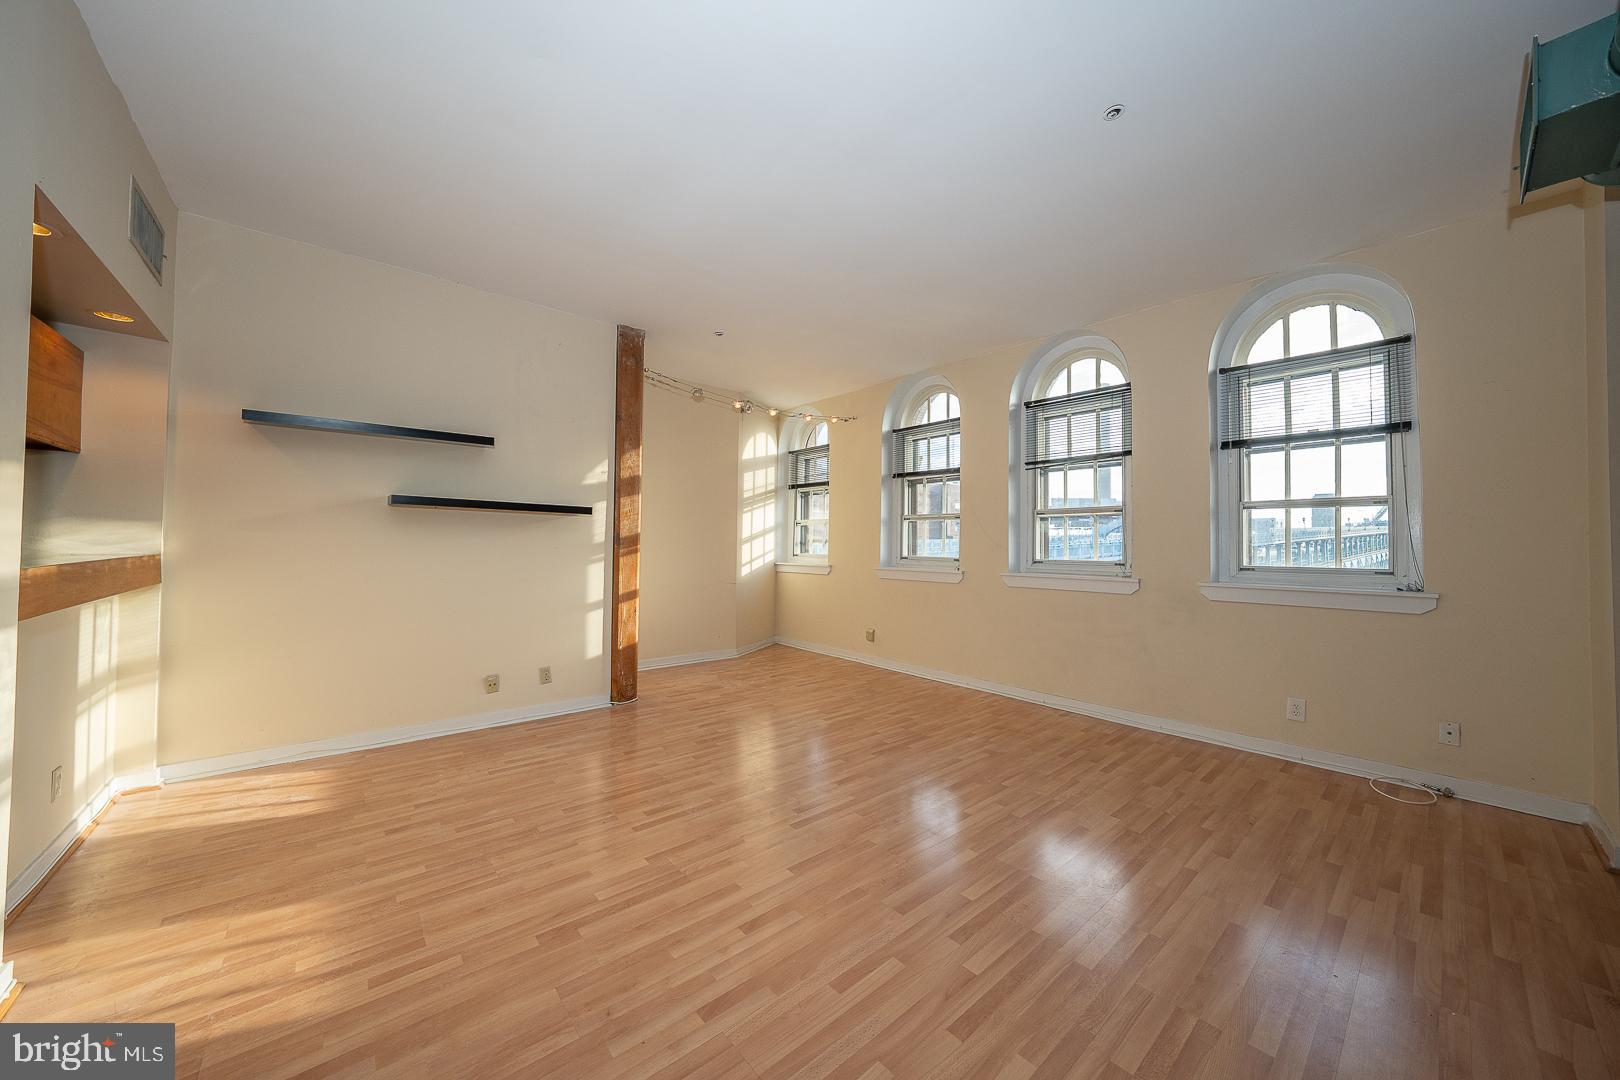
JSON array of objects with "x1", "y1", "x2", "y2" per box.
[{"x1": 5, "y1": 646, "x2": 1620, "y2": 1080}]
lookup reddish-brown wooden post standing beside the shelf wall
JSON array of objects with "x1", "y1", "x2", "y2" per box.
[{"x1": 611, "y1": 325, "x2": 646, "y2": 704}]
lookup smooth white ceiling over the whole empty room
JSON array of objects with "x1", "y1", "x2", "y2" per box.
[{"x1": 79, "y1": 0, "x2": 1612, "y2": 405}]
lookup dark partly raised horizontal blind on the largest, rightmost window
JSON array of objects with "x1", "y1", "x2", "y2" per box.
[{"x1": 1217, "y1": 334, "x2": 1416, "y2": 450}]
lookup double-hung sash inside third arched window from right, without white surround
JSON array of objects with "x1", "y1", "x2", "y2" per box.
[{"x1": 889, "y1": 390, "x2": 962, "y2": 560}]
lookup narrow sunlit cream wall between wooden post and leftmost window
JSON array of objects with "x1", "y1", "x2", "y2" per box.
[{"x1": 640, "y1": 385, "x2": 776, "y2": 664}]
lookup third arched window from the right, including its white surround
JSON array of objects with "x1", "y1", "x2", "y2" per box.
[{"x1": 881, "y1": 376, "x2": 962, "y2": 580}]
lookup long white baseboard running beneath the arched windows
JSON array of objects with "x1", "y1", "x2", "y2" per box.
[{"x1": 776, "y1": 638, "x2": 1594, "y2": 822}]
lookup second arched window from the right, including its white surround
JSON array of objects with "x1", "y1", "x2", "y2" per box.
[{"x1": 1006, "y1": 334, "x2": 1134, "y2": 593}]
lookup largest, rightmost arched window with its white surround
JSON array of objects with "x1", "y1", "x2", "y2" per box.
[{"x1": 1212, "y1": 267, "x2": 1427, "y2": 610}]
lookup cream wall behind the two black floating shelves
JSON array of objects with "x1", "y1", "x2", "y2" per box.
[{"x1": 159, "y1": 215, "x2": 614, "y2": 764}]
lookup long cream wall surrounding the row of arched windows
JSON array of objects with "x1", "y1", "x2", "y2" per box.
[{"x1": 778, "y1": 202, "x2": 1592, "y2": 801}]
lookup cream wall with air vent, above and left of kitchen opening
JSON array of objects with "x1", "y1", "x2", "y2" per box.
[{"x1": 0, "y1": 0, "x2": 175, "y2": 965}]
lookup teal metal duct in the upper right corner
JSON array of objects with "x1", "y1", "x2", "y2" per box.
[{"x1": 1520, "y1": 15, "x2": 1620, "y2": 202}]
